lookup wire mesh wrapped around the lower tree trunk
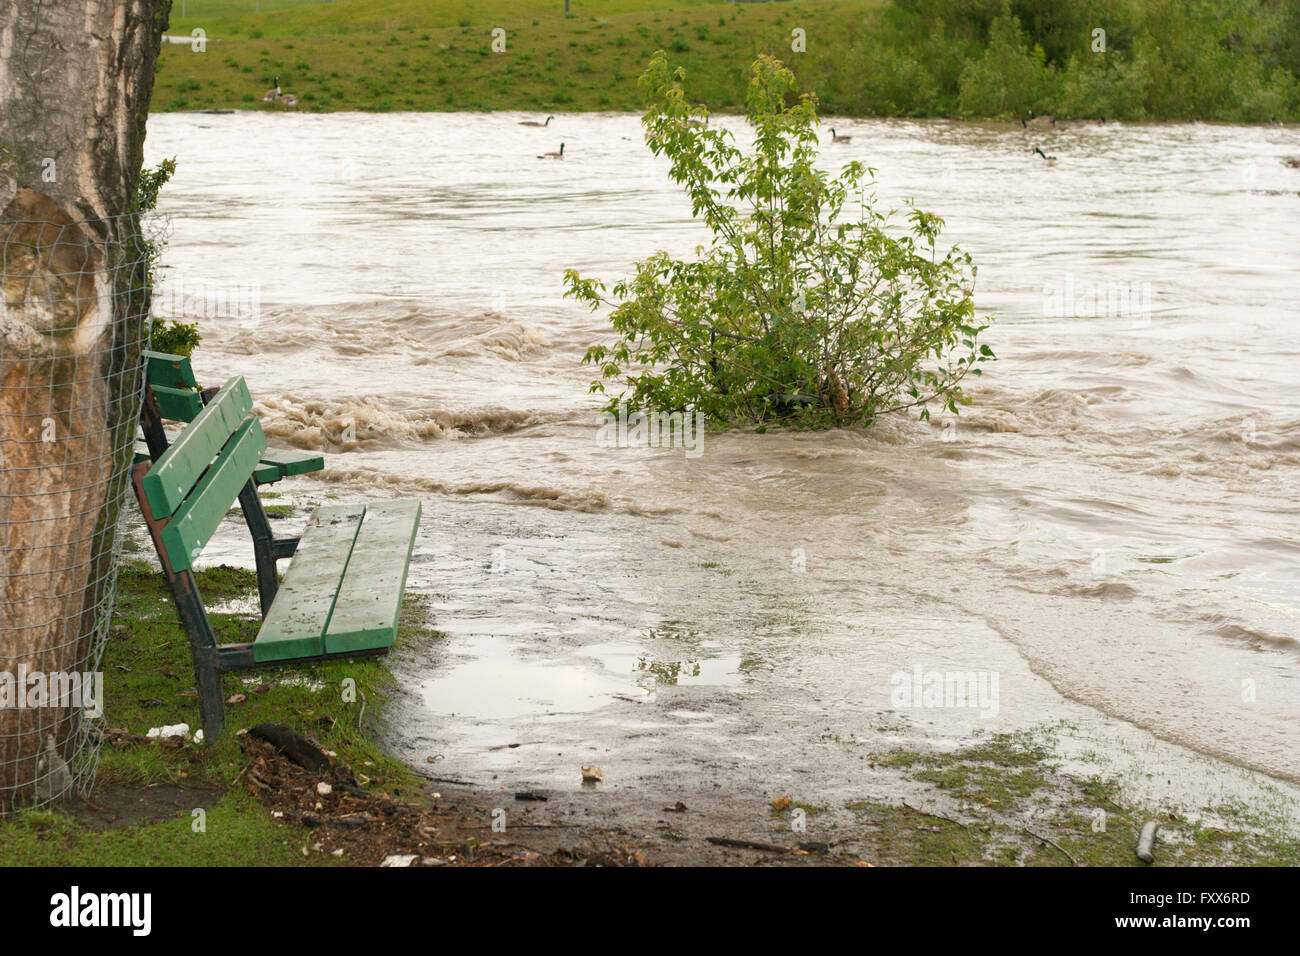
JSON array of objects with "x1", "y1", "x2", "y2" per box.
[{"x1": 0, "y1": 209, "x2": 155, "y2": 813}]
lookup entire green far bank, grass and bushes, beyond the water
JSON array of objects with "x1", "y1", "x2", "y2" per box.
[{"x1": 152, "y1": 0, "x2": 1300, "y2": 122}]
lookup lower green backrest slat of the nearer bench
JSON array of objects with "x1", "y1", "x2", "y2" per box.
[{"x1": 159, "y1": 416, "x2": 267, "y2": 571}]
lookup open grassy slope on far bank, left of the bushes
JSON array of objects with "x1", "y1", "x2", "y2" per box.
[{"x1": 153, "y1": 0, "x2": 880, "y2": 112}]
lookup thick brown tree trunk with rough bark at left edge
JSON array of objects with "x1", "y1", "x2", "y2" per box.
[{"x1": 0, "y1": 0, "x2": 172, "y2": 812}]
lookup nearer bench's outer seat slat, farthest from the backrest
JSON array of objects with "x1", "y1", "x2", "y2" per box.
[{"x1": 325, "y1": 498, "x2": 420, "y2": 654}]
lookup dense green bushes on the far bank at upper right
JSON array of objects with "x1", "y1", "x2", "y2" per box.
[{"x1": 800, "y1": 0, "x2": 1300, "y2": 122}]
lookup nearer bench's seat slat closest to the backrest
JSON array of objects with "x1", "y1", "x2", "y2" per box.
[{"x1": 252, "y1": 505, "x2": 365, "y2": 663}]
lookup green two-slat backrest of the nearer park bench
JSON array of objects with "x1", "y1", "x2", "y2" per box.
[{"x1": 140, "y1": 371, "x2": 267, "y2": 571}]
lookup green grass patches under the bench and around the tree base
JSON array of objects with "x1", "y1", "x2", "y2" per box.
[{"x1": 0, "y1": 561, "x2": 430, "y2": 866}]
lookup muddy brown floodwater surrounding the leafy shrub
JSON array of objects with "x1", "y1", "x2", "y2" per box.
[{"x1": 147, "y1": 113, "x2": 1300, "y2": 803}]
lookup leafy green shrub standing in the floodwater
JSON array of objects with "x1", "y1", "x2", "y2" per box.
[{"x1": 566, "y1": 51, "x2": 993, "y2": 425}]
